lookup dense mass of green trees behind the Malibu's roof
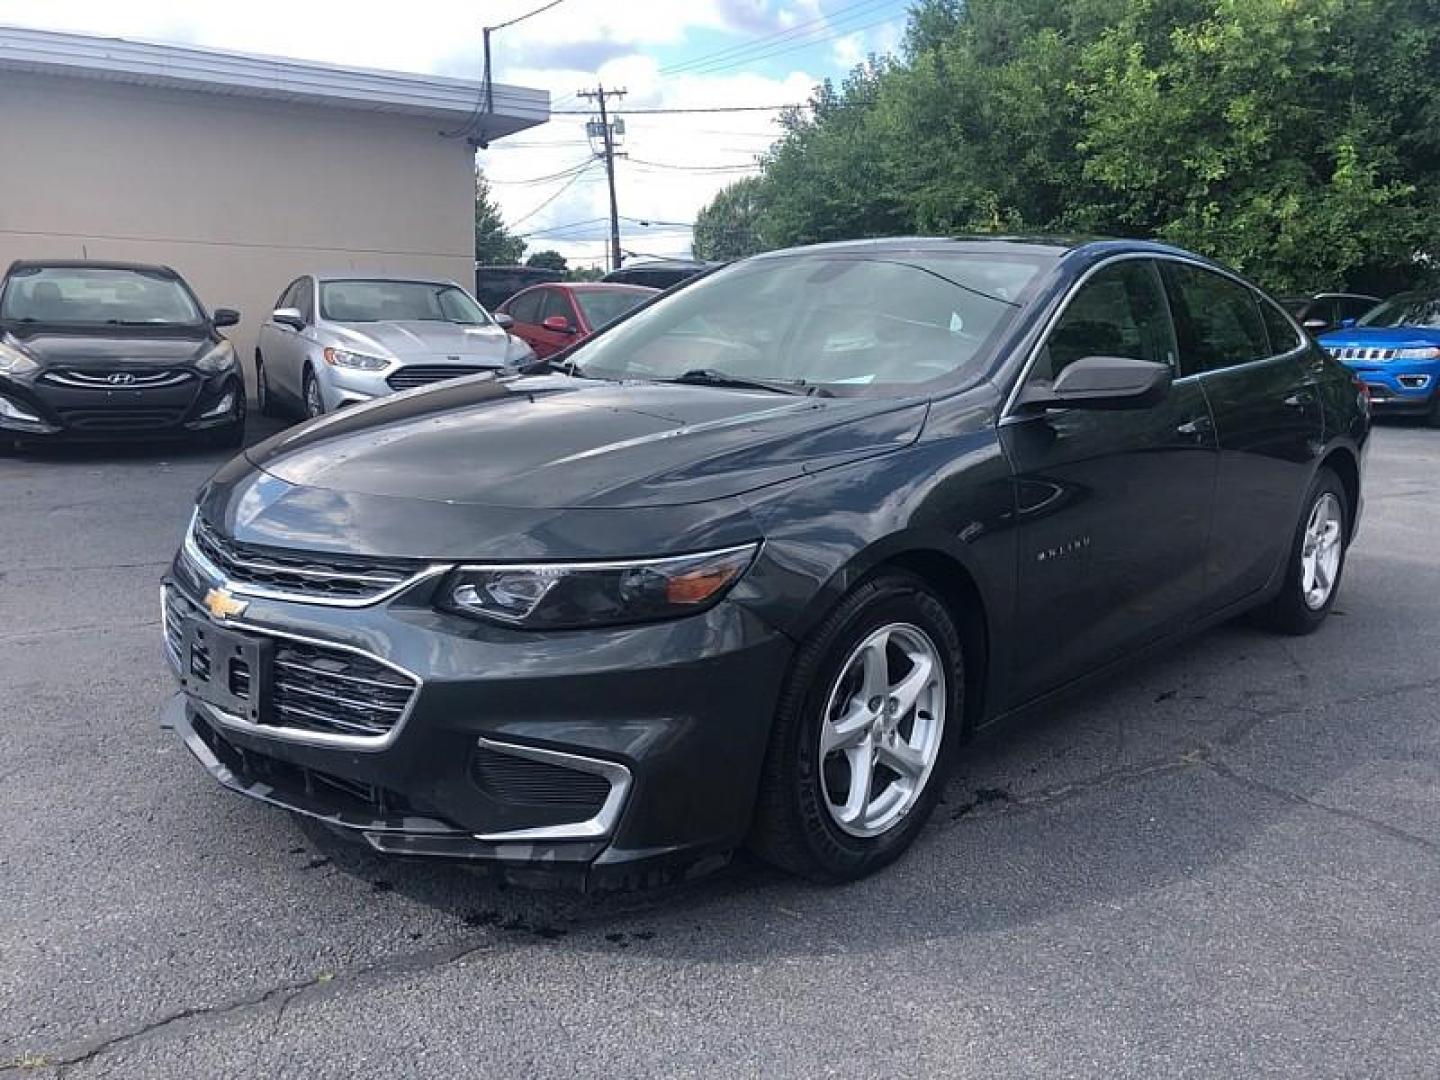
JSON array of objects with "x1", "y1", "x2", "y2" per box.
[{"x1": 697, "y1": 0, "x2": 1440, "y2": 291}]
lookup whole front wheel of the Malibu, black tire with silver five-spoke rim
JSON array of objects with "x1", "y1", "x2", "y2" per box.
[{"x1": 750, "y1": 572, "x2": 965, "y2": 881}]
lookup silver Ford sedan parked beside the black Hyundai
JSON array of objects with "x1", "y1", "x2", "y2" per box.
[{"x1": 255, "y1": 274, "x2": 534, "y2": 416}]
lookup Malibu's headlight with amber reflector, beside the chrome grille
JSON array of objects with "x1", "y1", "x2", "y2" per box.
[{"x1": 439, "y1": 543, "x2": 760, "y2": 629}]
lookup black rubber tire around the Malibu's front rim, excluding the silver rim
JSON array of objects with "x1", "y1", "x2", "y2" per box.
[{"x1": 775, "y1": 575, "x2": 965, "y2": 880}]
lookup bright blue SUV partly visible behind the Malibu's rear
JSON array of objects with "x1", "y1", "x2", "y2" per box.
[{"x1": 1320, "y1": 292, "x2": 1440, "y2": 428}]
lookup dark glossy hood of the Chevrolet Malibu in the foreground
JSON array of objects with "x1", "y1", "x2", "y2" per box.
[{"x1": 248, "y1": 374, "x2": 927, "y2": 508}]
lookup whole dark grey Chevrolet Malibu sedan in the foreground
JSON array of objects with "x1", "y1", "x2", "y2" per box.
[{"x1": 164, "y1": 239, "x2": 1369, "y2": 886}]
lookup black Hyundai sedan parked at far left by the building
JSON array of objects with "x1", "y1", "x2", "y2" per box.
[{"x1": 0, "y1": 261, "x2": 245, "y2": 446}]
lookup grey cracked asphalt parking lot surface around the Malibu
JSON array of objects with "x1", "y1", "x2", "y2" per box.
[{"x1": 0, "y1": 425, "x2": 1440, "y2": 1077}]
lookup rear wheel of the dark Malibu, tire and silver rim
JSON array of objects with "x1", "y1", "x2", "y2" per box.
[{"x1": 1256, "y1": 468, "x2": 1351, "y2": 635}]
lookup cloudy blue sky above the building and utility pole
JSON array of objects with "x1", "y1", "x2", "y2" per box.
[{"x1": 0, "y1": 0, "x2": 909, "y2": 265}]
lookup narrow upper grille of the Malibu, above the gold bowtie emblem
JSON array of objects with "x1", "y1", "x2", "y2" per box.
[{"x1": 190, "y1": 514, "x2": 423, "y2": 600}]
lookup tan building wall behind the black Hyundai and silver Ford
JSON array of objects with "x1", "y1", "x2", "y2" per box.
[{"x1": 0, "y1": 72, "x2": 474, "y2": 395}]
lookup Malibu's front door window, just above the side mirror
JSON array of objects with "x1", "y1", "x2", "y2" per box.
[{"x1": 1031, "y1": 259, "x2": 1175, "y2": 382}]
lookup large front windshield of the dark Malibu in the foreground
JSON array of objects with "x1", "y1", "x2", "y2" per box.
[{"x1": 570, "y1": 252, "x2": 1047, "y2": 395}]
